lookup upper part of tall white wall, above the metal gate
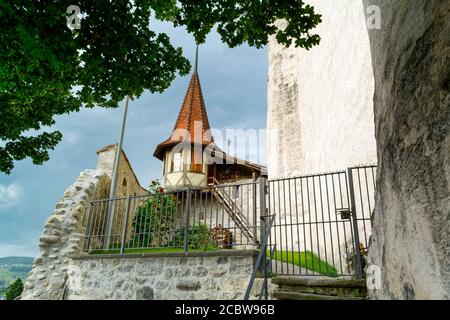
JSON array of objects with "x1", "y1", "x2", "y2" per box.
[{"x1": 267, "y1": 0, "x2": 377, "y2": 177}]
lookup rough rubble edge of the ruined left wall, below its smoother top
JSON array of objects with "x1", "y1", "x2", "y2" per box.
[{"x1": 21, "y1": 170, "x2": 111, "y2": 300}]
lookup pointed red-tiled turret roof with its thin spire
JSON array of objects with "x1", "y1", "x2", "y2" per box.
[{"x1": 153, "y1": 46, "x2": 213, "y2": 160}]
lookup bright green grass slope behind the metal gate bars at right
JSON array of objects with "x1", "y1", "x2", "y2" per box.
[{"x1": 267, "y1": 250, "x2": 338, "y2": 276}]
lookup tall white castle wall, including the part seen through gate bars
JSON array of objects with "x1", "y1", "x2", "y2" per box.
[{"x1": 267, "y1": 0, "x2": 377, "y2": 272}]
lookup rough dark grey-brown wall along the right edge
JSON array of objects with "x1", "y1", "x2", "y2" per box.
[{"x1": 364, "y1": 0, "x2": 450, "y2": 299}]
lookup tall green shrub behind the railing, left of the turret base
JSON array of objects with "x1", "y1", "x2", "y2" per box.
[{"x1": 128, "y1": 180, "x2": 177, "y2": 248}]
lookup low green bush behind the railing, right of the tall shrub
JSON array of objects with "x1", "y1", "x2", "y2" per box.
[{"x1": 172, "y1": 224, "x2": 217, "y2": 250}]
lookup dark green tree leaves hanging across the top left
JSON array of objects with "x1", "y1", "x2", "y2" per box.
[{"x1": 0, "y1": 0, "x2": 321, "y2": 173}]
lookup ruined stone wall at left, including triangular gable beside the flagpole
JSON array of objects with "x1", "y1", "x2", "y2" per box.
[{"x1": 22, "y1": 145, "x2": 146, "y2": 299}]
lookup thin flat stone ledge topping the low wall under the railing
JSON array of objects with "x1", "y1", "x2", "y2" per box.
[{"x1": 71, "y1": 249, "x2": 259, "y2": 260}]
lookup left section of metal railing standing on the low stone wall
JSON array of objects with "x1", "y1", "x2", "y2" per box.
[{"x1": 83, "y1": 181, "x2": 259, "y2": 253}]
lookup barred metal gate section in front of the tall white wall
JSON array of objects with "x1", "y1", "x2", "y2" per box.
[{"x1": 266, "y1": 166, "x2": 376, "y2": 277}]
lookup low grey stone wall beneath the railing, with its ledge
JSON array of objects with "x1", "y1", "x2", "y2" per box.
[{"x1": 64, "y1": 250, "x2": 260, "y2": 300}]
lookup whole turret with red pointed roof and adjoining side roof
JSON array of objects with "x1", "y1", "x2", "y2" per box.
[{"x1": 153, "y1": 48, "x2": 267, "y2": 189}]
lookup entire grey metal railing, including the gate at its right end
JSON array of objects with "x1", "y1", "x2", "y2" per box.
[{"x1": 83, "y1": 166, "x2": 376, "y2": 297}]
